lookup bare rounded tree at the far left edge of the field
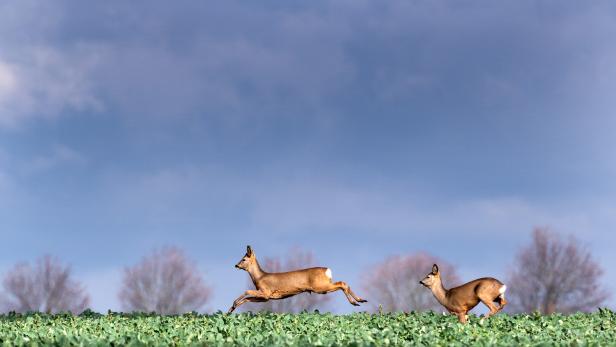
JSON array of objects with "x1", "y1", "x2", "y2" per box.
[{"x1": 2, "y1": 256, "x2": 90, "y2": 314}]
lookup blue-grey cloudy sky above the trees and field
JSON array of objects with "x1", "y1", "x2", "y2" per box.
[{"x1": 0, "y1": 0, "x2": 616, "y2": 312}]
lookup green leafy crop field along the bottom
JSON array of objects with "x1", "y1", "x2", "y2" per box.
[{"x1": 0, "y1": 309, "x2": 616, "y2": 346}]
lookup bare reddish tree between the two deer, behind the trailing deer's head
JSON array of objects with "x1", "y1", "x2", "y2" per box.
[{"x1": 362, "y1": 253, "x2": 460, "y2": 312}]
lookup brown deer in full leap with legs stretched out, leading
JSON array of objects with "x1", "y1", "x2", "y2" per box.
[{"x1": 228, "y1": 246, "x2": 367, "y2": 313}]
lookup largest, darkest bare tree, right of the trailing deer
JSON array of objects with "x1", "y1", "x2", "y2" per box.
[{"x1": 507, "y1": 228, "x2": 609, "y2": 314}]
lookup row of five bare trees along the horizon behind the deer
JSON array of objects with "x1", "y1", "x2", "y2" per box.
[{"x1": 0, "y1": 228, "x2": 610, "y2": 314}]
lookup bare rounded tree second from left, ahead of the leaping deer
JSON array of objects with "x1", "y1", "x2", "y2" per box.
[{"x1": 118, "y1": 247, "x2": 211, "y2": 314}]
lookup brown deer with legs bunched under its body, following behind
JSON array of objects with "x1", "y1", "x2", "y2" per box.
[{"x1": 419, "y1": 264, "x2": 507, "y2": 323}]
